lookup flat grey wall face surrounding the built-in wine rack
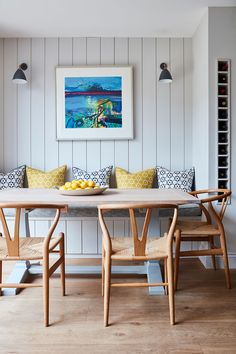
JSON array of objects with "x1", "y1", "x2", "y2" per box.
[{"x1": 209, "y1": 7, "x2": 236, "y2": 254}]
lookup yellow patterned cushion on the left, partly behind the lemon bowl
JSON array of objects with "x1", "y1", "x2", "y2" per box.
[{"x1": 26, "y1": 166, "x2": 67, "y2": 188}]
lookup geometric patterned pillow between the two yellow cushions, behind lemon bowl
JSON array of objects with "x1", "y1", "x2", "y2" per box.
[{"x1": 72, "y1": 166, "x2": 113, "y2": 186}]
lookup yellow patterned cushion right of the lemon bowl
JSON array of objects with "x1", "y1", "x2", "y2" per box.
[{"x1": 115, "y1": 167, "x2": 155, "y2": 188}]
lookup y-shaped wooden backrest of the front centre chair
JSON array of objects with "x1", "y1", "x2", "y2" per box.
[{"x1": 98, "y1": 204, "x2": 178, "y2": 257}]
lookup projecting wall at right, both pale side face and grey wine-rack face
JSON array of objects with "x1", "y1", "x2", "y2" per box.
[{"x1": 192, "y1": 7, "x2": 236, "y2": 268}]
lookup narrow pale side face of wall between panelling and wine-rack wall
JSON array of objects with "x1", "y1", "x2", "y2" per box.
[{"x1": 192, "y1": 13, "x2": 209, "y2": 189}]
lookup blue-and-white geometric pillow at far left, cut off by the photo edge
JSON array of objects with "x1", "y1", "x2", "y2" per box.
[{"x1": 0, "y1": 165, "x2": 25, "y2": 190}]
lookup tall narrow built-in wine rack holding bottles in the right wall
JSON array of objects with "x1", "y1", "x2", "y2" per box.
[{"x1": 216, "y1": 59, "x2": 230, "y2": 196}]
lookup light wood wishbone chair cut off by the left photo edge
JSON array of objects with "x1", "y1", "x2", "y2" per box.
[{"x1": 0, "y1": 204, "x2": 67, "y2": 327}]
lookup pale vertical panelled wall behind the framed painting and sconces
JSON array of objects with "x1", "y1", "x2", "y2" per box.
[{"x1": 0, "y1": 38, "x2": 192, "y2": 177}]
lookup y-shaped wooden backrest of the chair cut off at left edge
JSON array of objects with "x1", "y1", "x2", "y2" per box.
[{"x1": 0, "y1": 204, "x2": 67, "y2": 257}]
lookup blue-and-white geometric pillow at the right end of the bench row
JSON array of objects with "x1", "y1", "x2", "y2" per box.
[{"x1": 157, "y1": 167, "x2": 194, "y2": 192}]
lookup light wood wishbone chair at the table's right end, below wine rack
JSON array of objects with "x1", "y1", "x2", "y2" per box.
[{"x1": 175, "y1": 189, "x2": 231, "y2": 289}]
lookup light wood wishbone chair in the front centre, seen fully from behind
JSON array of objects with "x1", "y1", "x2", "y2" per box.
[{"x1": 98, "y1": 204, "x2": 178, "y2": 326}]
